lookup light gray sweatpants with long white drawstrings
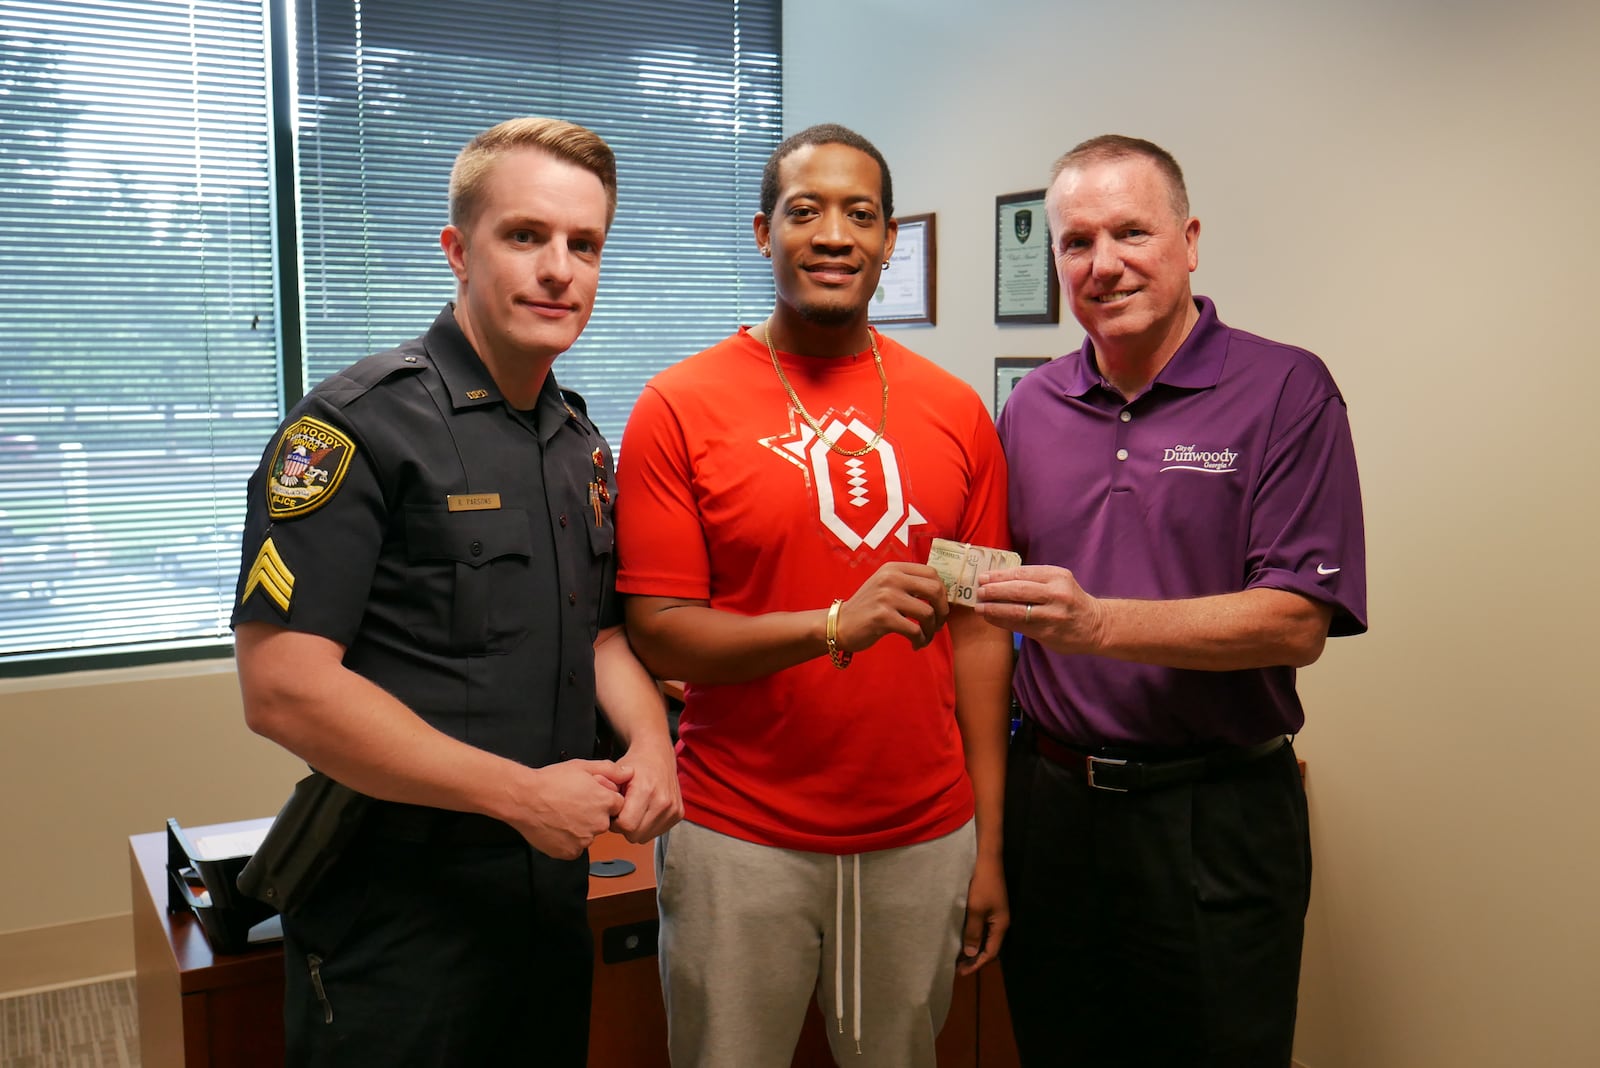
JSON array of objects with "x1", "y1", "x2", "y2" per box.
[{"x1": 656, "y1": 820, "x2": 978, "y2": 1068}]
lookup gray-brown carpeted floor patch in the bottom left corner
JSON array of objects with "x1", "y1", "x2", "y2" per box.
[{"x1": 0, "y1": 975, "x2": 139, "y2": 1068}]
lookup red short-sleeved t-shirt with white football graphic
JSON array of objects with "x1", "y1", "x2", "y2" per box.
[{"x1": 616, "y1": 328, "x2": 1010, "y2": 854}]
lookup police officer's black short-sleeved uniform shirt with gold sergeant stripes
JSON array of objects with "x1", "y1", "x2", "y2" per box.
[{"x1": 234, "y1": 307, "x2": 621, "y2": 766}]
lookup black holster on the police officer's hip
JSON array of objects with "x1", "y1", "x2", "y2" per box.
[{"x1": 237, "y1": 771, "x2": 373, "y2": 915}]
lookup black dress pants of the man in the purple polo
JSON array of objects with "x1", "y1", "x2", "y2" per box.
[{"x1": 1002, "y1": 735, "x2": 1310, "y2": 1068}]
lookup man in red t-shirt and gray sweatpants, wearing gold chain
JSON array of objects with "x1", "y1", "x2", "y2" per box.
[{"x1": 616, "y1": 126, "x2": 1011, "y2": 1068}]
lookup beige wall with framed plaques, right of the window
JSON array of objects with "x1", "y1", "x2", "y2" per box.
[{"x1": 784, "y1": 0, "x2": 1600, "y2": 1068}]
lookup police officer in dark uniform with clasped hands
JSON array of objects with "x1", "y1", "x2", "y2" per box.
[{"x1": 234, "y1": 118, "x2": 682, "y2": 1065}]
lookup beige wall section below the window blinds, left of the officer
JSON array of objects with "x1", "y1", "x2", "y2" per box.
[{"x1": 0, "y1": 660, "x2": 306, "y2": 946}]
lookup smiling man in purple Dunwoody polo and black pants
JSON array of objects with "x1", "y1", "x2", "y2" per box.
[{"x1": 979, "y1": 136, "x2": 1366, "y2": 1068}]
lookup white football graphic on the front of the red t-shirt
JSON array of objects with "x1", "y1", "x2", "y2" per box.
[{"x1": 760, "y1": 408, "x2": 928, "y2": 550}]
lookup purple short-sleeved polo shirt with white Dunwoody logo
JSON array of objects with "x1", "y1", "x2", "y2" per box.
[{"x1": 1000, "y1": 297, "x2": 1366, "y2": 747}]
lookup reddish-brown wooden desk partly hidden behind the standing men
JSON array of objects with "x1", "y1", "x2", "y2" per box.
[{"x1": 128, "y1": 820, "x2": 1018, "y2": 1068}]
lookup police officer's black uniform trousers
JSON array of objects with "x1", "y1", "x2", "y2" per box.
[{"x1": 283, "y1": 836, "x2": 594, "y2": 1068}]
